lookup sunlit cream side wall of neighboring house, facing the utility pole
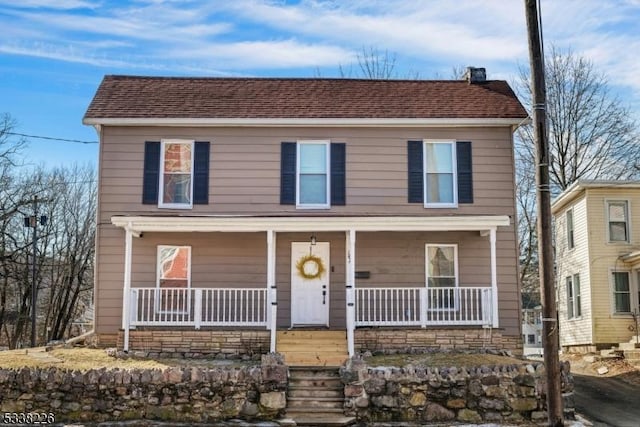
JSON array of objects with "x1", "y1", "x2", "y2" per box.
[{"x1": 555, "y1": 197, "x2": 593, "y2": 346}]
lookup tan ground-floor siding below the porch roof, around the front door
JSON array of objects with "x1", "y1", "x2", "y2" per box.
[{"x1": 97, "y1": 228, "x2": 519, "y2": 336}]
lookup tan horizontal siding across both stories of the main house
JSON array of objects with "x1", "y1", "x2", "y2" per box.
[{"x1": 96, "y1": 127, "x2": 520, "y2": 336}]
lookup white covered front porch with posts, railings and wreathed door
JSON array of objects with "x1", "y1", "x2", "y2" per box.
[{"x1": 112, "y1": 216, "x2": 510, "y2": 355}]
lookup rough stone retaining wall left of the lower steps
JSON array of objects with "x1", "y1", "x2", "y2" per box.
[{"x1": 0, "y1": 355, "x2": 288, "y2": 423}]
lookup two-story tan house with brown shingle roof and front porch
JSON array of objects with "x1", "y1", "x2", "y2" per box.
[{"x1": 83, "y1": 69, "x2": 527, "y2": 360}]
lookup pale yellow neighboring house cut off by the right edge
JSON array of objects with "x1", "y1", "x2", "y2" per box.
[{"x1": 551, "y1": 180, "x2": 640, "y2": 351}]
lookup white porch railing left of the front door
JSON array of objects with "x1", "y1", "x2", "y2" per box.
[{"x1": 130, "y1": 288, "x2": 267, "y2": 329}]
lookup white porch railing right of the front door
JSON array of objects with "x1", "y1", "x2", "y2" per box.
[{"x1": 356, "y1": 287, "x2": 493, "y2": 327}]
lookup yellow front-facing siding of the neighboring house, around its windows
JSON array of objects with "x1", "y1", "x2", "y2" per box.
[{"x1": 586, "y1": 188, "x2": 640, "y2": 344}]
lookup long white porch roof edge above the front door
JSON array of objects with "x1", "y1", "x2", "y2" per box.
[{"x1": 111, "y1": 215, "x2": 511, "y2": 233}]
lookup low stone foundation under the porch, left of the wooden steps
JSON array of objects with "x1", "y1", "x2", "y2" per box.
[{"x1": 117, "y1": 329, "x2": 270, "y2": 358}]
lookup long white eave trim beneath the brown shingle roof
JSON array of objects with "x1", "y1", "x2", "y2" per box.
[{"x1": 82, "y1": 117, "x2": 530, "y2": 128}]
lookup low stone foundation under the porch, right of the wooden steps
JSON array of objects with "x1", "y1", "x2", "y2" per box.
[{"x1": 355, "y1": 328, "x2": 522, "y2": 355}]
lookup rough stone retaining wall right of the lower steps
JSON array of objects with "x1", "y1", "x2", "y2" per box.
[{"x1": 341, "y1": 359, "x2": 575, "y2": 423}]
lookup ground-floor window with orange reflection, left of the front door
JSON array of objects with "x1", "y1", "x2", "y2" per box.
[{"x1": 156, "y1": 246, "x2": 191, "y2": 313}]
